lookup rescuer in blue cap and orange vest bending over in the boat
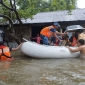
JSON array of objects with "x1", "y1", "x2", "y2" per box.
[{"x1": 40, "y1": 22, "x2": 66, "y2": 45}]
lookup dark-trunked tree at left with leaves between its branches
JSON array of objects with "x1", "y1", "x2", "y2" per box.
[{"x1": 0, "y1": 0, "x2": 22, "y2": 44}]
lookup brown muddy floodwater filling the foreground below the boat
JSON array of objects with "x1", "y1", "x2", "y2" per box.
[{"x1": 0, "y1": 51, "x2": 85, "y2": 85}]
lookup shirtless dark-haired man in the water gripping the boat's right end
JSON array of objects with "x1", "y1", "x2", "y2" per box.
[{"x1": 66, "y1": 39, "x2": 85, "y2": 59}]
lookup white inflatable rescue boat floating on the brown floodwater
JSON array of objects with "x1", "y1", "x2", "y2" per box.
[{"x1": 20, "y1": 40, "x2": 80, "y2": 58}]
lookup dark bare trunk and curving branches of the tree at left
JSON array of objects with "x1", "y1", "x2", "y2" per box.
[{"x1": 0, "y1": 0, "x2": 22, "y2": 44}]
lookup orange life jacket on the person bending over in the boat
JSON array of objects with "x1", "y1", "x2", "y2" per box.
[{"x1": 40, "y1": 26, "x2": 54, "y2": 38}]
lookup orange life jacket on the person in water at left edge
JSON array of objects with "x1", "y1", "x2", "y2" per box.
[{"x1": 0, "y1": 45, "x2": 12, "y2": 60}]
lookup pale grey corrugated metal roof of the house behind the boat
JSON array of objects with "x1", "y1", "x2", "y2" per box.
[{"x1": 22, "y1": 9, "x2": 85, "y2": 24}]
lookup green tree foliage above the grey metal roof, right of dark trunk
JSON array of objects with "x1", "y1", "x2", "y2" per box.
[{"x1": 17, "y1": 0, "x2": 76, "y2": 17}]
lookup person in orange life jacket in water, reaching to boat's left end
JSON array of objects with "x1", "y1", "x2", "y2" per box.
[{"x1": 0, "y1": 42, "x2": 22, "y2": 61}]
